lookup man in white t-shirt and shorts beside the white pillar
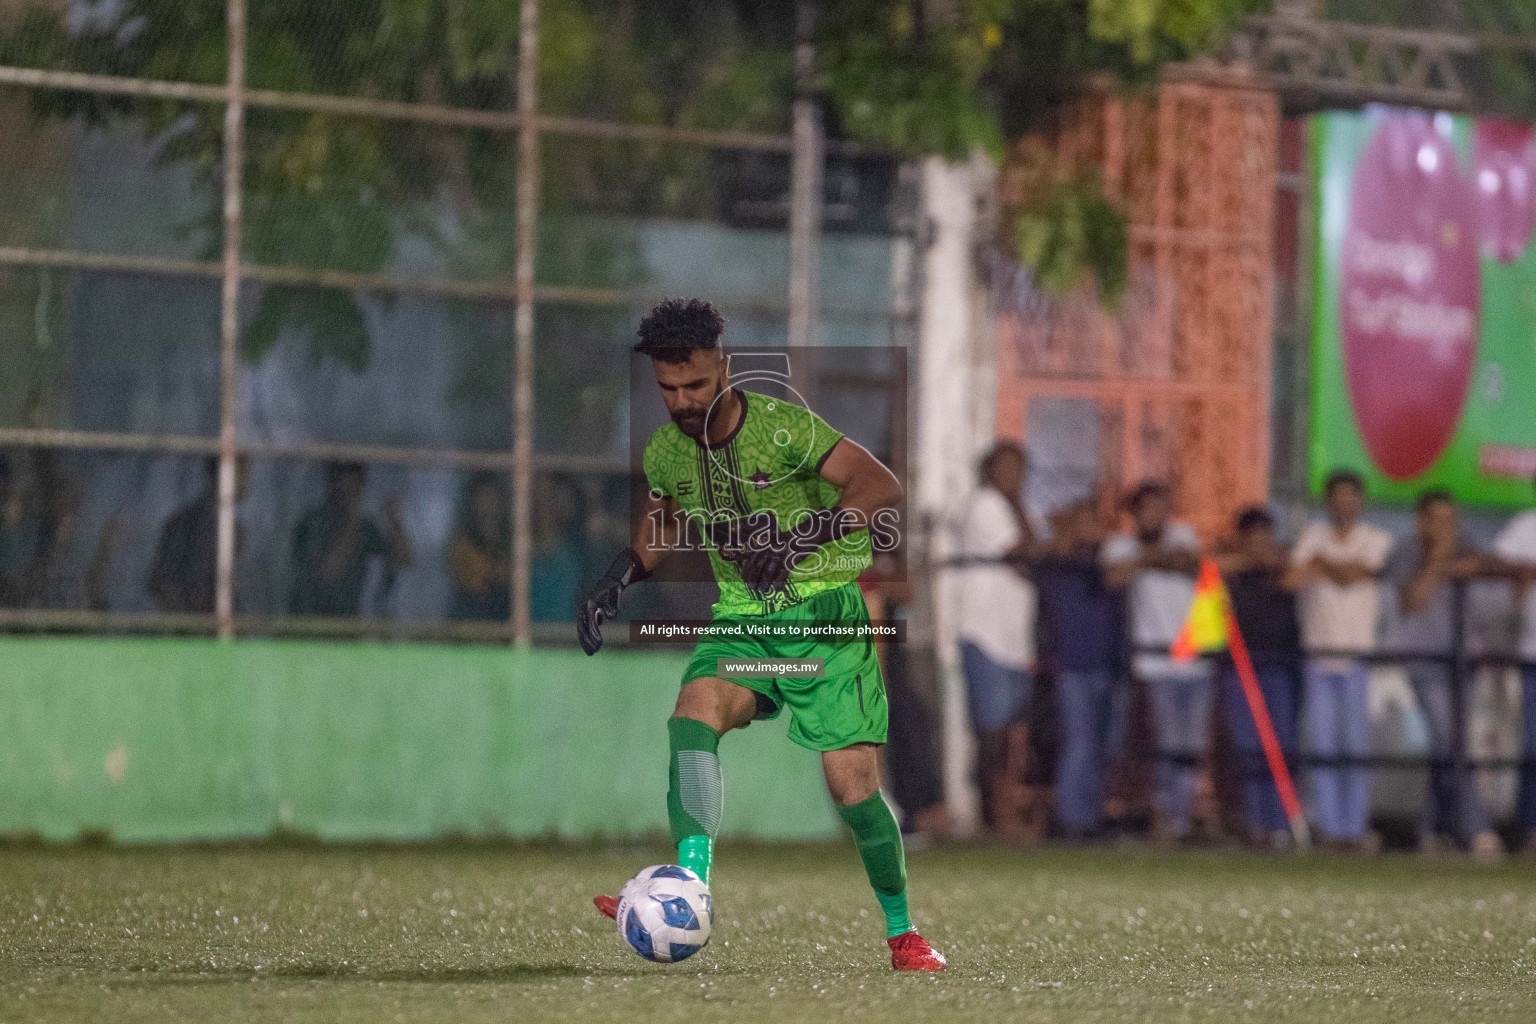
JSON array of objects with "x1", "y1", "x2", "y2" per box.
[{"x1": 955, "y1": 441, "x2": 1037, "y2": 838}]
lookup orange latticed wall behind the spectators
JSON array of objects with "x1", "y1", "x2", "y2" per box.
[{"x1": 997, "y1": 74, "x2": 1279, "y2": 540}]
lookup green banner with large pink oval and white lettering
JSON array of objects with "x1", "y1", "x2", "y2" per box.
[{"x1": 1310, "y1": 107, "x2": 1536, "y2": 505}]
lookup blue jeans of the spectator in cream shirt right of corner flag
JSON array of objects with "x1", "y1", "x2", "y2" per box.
[{"x1": 1303, "y1": 660, "x2": 1370, "y2": 840}]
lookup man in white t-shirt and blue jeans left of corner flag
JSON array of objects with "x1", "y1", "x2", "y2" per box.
[{"x1": 1103, "y1": 482, "x2": 1210, "y2": 841}]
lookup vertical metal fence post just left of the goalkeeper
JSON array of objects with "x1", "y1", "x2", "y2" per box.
[{"x1": 510, "y1": 0, "x2": 539, "y2": 646}]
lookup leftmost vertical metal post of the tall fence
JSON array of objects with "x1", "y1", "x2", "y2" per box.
[{"x1": 214, "y1": 0, "x2": 246, "y2": 639}]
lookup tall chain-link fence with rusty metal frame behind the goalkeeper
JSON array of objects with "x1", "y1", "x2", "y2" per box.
[{"x1": 0, "y1": 0, "x2": 911, "y2": 640}]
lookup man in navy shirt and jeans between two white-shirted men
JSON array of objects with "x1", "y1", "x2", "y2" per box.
[{"x1": 1035, "y1": 500, "x2": 1124, "y2": 840}]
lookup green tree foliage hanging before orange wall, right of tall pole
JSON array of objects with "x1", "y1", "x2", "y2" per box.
[{"x1": 819, "y1": 0, "x2": 1267, "y2": 302}]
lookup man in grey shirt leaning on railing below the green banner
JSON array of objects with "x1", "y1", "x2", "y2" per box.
[{"x1": 1385, "y1": 490, "x2": 1504, "y2": 860}]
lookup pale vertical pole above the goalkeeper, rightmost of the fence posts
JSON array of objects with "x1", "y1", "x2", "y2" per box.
[{"x1": 790, "y1": 0, "x2": 826, "y2": 347}]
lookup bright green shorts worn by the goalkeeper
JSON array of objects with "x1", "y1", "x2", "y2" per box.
[{"x1": 682, "y1": 583, "x2": 889, "y2": 751}]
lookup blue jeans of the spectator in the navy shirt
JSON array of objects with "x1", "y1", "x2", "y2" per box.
[{"x1": 1057, "y1": 669, "x2": 1118, "y2": 835}]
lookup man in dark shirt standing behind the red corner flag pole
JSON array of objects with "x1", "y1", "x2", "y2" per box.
[{"x1": 1217, "y1": 507, "x2": 1301, "y2": 849}]
